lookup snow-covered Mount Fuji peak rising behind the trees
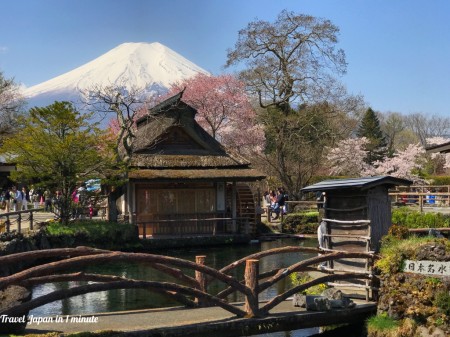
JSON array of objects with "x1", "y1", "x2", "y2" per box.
[{"x1": 23, "y1": 42, "x2": 209, "y2": 107}]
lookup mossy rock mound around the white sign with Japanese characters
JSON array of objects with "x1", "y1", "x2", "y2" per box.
[{"x1": 373, "y1": 239, "x2": 450, "y2": 336}]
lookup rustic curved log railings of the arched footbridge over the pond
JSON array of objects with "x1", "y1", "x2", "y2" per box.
[{"x1": 0, "y1": 247, "x2": 374, "y2": 334}]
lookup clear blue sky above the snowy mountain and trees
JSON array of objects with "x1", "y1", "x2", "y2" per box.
[{"x1": 0, "y1": 0, "x2": 450, "y2": 116}]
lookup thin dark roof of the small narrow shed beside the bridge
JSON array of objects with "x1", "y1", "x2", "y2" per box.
[{"x1": 302, "y1": 176, "x2": 412, "y2": 192}]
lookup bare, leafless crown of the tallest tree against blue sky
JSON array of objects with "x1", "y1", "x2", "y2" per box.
[{"x1": 226, "y1": 10, "x2": 347, "y2": 112}]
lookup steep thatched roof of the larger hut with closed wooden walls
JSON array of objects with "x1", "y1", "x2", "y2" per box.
[{"x1": 130, "y1": 93, "x2": 264, "y2": 180}]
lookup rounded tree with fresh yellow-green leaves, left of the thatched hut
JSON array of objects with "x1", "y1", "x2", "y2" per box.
[{"x1": 1, "y1": 102, "x2": 110, "y2": 223}]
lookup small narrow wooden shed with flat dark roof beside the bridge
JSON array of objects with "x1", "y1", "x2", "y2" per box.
[{"x1": 302, "y1": 176, "x2": 412, "y2": 299}]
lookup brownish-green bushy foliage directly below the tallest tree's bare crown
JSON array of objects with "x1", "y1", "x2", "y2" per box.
[{"x1": 260, "y1": 104, "x2": 342, "y2": 199}]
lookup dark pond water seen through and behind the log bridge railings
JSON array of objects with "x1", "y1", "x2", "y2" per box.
[{"x1": 30, "y1": 239, "x2": 366, "y2": 337}]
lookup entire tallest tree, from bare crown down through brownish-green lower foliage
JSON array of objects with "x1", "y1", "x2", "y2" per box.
[{"x1": 226, "y1": 10, "x2": 361, "y2": 198}]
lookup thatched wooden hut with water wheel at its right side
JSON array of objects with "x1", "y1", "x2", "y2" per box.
[{"x1": 118, "y1": 92, "x2": 265, "y2": 236}]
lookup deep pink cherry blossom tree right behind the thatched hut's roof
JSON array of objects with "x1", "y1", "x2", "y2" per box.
[{"x1": 168, "y1": 74, "x2": 264, "y2": 153}]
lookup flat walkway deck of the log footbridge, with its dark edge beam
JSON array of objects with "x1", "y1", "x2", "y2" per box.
[{"x1": 25, "y1": 301, "x2": 376, "y2": 337}]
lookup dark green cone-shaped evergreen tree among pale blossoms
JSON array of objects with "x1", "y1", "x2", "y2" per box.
[{"x1": 356, "y1": 108, "x2": 388, "y2": 165}]
